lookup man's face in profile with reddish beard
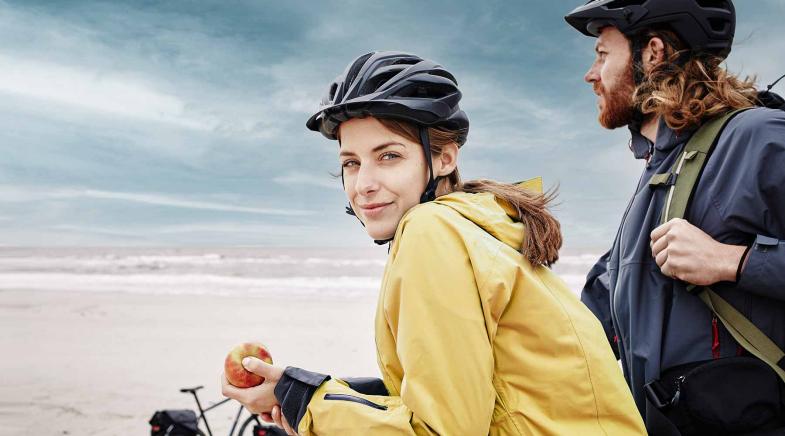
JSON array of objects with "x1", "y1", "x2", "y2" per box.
[{"x1": 583, "y1": 27, "x2": 635, "y2": 129}]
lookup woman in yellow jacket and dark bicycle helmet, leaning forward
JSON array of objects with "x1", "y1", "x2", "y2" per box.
[{"x1": 224, "y1": 52, "x2": 645, "y2": 435}]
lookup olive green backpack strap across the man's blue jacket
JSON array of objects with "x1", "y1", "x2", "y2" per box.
[{"x1": 649, "y1": 109, "x2": 785, "y2": 381}]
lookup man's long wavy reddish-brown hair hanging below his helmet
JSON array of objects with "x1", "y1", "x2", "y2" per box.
[{"x1": 631, "y1": 29, "x2": 757, "y2": 133}]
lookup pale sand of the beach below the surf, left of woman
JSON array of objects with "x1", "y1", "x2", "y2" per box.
[{"x1": 0, "y1": 286, "x2": 378, "y2": 436}]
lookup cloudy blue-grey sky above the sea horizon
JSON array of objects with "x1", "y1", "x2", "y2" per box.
[{"x1": 0, "y1": 0, "x2": 785, "y2": 249}]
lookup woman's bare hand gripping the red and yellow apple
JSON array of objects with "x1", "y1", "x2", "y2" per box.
[{"x1": 221, "y1": 357, "x2": 283, "y2": 417}]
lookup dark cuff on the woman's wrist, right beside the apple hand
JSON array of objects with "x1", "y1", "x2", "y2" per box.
[{"x1": 274, "y1": 366, "x2": 330, "y2": 431}]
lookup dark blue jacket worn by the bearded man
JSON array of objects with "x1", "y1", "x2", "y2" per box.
[{"x1": 581, "y1": 108, "x2": 785, "y2": 414}]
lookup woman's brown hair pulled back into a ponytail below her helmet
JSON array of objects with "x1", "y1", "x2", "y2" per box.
[{"x1": 378, "y1": 119, "x2": 562, "y2": 266}]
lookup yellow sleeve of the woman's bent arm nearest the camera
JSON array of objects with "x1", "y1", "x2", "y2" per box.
[{"x1": 290, "y1": 208, "x2": 496, "y2": 435}]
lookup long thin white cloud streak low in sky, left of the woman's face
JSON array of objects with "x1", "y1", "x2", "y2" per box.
[{"x1": 0, "y1": 186, "x2": 316, "y2": 216}]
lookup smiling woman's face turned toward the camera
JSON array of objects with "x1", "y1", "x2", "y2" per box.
[{"x1": 339, "y1": 117, "x2": 428, "y2": 240}]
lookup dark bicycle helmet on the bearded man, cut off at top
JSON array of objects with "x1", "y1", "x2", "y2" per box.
[{"x1": 564, "y1": 0, "x2": 736, "y2": 58}]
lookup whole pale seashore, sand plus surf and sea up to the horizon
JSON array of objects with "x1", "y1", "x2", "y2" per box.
[{"x1": 0, "y1": 247, "x2": 596, "y2": 436}]
